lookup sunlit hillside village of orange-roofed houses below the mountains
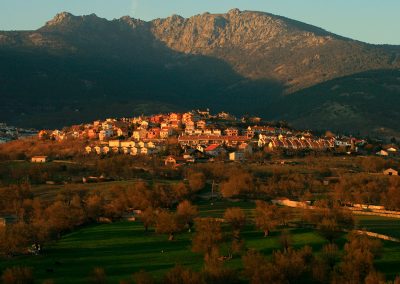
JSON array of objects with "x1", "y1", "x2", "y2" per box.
[{"x1": 34, "y1": 109, "x2": 398, "y2": 166}]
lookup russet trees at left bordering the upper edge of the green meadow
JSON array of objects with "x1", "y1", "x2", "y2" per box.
[{"x1": 0, "y1": 182, "x2": 202, "y2": 256}]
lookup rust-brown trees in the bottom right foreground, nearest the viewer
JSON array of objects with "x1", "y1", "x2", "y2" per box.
[{"x1": 243, "y1": 234, "x2": 385, "y2": 283}]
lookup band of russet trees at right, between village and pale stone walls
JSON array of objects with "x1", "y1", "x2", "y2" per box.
[{"x1": 192, "y1": 157, "x2": 400, "y2": 210}]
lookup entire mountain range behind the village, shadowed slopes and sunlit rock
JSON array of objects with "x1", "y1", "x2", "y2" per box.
[{"x1": 0, "y1": 9, "x2": 400, "y2": 136}]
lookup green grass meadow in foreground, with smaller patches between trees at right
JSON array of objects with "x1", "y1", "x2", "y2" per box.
[{"x1": 0, "y1": 200, "x2": 400, "y2": 283}]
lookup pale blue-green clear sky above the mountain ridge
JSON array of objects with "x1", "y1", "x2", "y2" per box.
[{"x1": 0, "y1": 0, "x2": 400, "y2": 44}]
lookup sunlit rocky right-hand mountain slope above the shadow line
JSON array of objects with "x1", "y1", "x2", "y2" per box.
[{"x1": 151, "y1": 9, "x2": 400, "y2": 92}]
